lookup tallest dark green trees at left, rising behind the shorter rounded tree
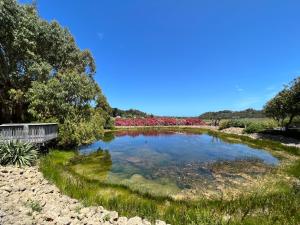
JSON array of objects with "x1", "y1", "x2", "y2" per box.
[{"x1": 0, "y1": 0, "x2": 95, "y2": 123}]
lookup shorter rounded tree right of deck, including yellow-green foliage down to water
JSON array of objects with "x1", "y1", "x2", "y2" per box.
[{"x1": 27, "y1": 71, "x2": 112, "y2": 146}]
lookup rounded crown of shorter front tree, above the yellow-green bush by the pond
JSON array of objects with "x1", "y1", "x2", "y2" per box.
[{"x1": 26, "y1": 71, "x2": 98, "y2": 123}]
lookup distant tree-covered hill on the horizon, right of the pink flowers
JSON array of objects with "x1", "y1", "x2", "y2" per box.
[{"x1": 199, "y1": 109, "x2": 266, "y2": 119}]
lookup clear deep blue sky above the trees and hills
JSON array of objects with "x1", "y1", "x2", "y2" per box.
[{"x1": 21, "y1": 0, "x2": 300, "y2": 116}]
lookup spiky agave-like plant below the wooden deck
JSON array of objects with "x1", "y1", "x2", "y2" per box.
[{"x1": 0, "y1": 141, "x2": 38, "y2": 167}]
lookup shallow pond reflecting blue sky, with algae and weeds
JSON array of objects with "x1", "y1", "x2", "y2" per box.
[{"x1": 77, "y1": 130, "x2": 279, "y2": 198}]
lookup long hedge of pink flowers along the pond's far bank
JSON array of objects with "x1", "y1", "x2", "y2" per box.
[{"x1": 115, "y1": 117, "x2": 205, "y2": 127}]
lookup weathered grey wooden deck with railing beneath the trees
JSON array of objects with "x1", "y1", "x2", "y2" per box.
[{"x1": 0, "y1": 123, "x2": 58, "y2": 144}]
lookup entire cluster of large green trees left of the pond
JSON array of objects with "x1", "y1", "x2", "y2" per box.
[{"x1": 0, "y1": 0, "x2": 112, "y2": 145}]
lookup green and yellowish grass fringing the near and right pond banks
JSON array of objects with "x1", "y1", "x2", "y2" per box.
[{"x1": 40, "y1": 128, "x2": 300, "y2": 225}]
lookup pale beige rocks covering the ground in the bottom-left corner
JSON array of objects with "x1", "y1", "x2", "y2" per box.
[{"x1": 0, "y1": 166, "x2": 166, "y2": 225}]
